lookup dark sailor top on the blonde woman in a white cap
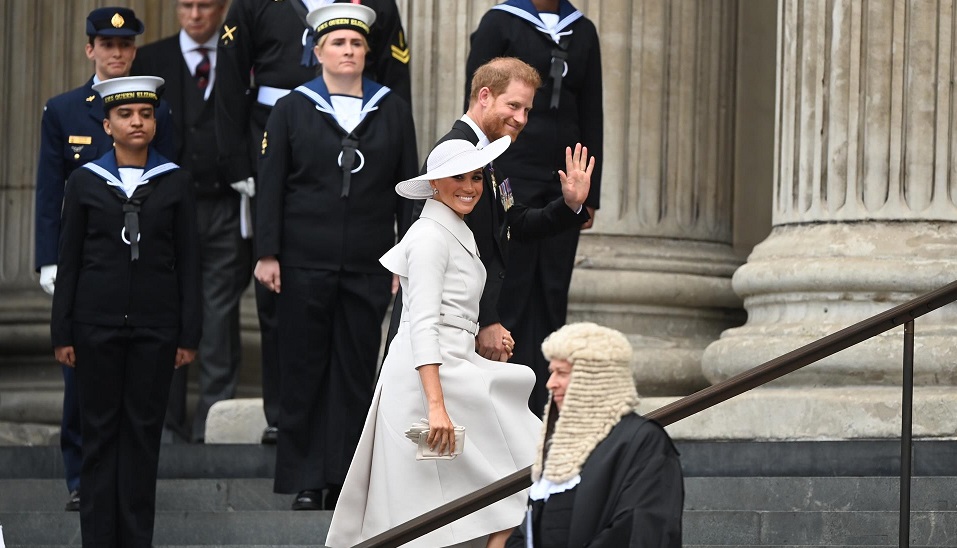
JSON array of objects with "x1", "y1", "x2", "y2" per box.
[{"x1": 255, "y1": 77, "x2": 418, "y2": 273}]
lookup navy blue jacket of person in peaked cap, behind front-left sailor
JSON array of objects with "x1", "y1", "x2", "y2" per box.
[{"x1": 34, "y1": 78, "x2": 176, "y2": 271}]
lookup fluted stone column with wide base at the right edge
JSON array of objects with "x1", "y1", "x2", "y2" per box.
[{"x1": 689, "y1": 0, "x2": 957, "y2": 438}]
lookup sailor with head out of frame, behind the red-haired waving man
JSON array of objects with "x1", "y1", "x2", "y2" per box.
[{"x1": 466, "y1": 0, "x2": 603, "y2": 413}]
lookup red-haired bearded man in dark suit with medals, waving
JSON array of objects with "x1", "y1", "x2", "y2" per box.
[{"x1": 388, "y1": 57, "x2": 595, "y2": 361}]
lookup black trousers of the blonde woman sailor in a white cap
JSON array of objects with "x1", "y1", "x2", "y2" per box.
[{"x1": 274, "y1": 267, "x2": 392, "y2": 493}]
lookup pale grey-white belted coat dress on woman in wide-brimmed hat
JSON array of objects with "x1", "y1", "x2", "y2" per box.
[{"x1": 326, "y1": 197, "x2": 542, "y2": 548}]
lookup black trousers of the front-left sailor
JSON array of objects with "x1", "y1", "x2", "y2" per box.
[{"x1": 74, "y1": 323, "x2": 178, "y2": 548}]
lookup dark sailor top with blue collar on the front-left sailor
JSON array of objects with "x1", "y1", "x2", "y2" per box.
[{"x1": 51, "y1": 149, "x2": 202, "y2": 348}]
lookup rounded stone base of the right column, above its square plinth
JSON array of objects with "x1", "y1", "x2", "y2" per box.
[{"x1": 702, "y1": 222, "x2": 957, "y2": 386}]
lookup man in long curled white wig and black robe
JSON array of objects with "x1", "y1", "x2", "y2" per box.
[{"x1": 507, "y1": 323, "x2": 684, "y2": 548}]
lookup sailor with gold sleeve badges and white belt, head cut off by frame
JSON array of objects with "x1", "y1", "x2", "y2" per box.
[{"x1": 216, "y1": 0, "x2": 412, "y2": 443}]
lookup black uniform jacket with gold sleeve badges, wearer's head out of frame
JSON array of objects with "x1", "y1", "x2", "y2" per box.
[{"x1": 216, "y1": 0, "x2": 412, "y2": 182}]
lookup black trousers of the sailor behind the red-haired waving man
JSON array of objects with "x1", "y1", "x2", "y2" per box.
[{"x1": 498, "y1": 181, "x2": 581, "y2": 416}]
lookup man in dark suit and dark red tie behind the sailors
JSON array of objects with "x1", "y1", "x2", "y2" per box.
[{"x1": 133, "y1": 0, "x2": 252, "y2": 441}]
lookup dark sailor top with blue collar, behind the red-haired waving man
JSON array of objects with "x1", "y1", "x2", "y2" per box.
[{"x1": 465, "y1": 0, "x2": 604, "y2": 209}]
